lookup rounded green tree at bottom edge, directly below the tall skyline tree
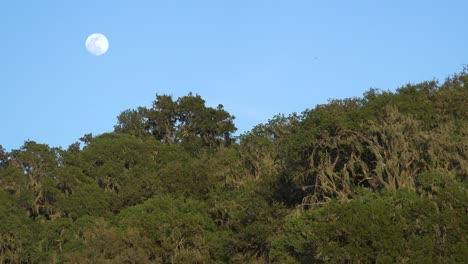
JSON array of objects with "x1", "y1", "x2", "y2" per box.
[{"x1": 116, "y1": 194, "x2": 213, "y2": 263}]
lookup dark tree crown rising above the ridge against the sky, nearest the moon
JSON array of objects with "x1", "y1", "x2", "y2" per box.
[{"x1": 115, "y1": 93, "x2": 236, "y2": 148}]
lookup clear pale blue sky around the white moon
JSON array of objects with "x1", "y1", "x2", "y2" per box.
[{"x1": 0, "y1": 0, "x2": 468, "y2": 150}]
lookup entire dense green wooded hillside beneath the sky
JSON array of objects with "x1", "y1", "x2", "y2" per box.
[{"x1": 0, "y1": 70, "x2": 468, "y2": 263}]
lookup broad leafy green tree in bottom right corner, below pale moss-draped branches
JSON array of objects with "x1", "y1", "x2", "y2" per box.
[{"x1": 270, "y1": 184, "x2": 468, "y2": 263}]
